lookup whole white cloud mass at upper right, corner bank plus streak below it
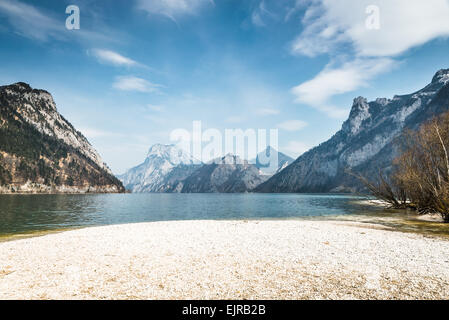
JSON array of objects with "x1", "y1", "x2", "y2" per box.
[{"x1": 287, "y1": 0, "x2": 449, "y2": 118}]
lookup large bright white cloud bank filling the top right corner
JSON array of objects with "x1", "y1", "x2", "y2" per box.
[{"x1": 293, "y1": 0, "x2": 449, "y2": 57}]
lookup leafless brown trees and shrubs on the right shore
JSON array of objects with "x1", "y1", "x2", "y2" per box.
[{"x1": 352, "y1": 112, "x2": 449, "y2": 222}]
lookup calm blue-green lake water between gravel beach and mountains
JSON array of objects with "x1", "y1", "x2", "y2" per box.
[{"x1": 0, "y1": 194, "x2": 449, "y2": 236}]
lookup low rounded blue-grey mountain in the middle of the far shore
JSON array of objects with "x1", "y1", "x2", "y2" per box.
[{"x1": 181, "y1": 154, "x2": 266, "y2": 193}]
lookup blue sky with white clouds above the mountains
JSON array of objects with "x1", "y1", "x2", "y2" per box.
[{"x1": 0, "y1": 0, "x2": 449, "y2": 173}]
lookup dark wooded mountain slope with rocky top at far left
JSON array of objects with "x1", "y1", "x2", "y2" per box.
[{"x1": 0, "y1": 82, "x2": 124, "y2": 193}]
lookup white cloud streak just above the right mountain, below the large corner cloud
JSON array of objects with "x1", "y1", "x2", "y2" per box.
[{"x1": 292, "y1": 58, "x2": 395, "y2": 118}]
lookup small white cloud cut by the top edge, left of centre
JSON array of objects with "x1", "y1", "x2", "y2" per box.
[{"x1": 137, "y1": 0, "x2": 214, "y2": 21}]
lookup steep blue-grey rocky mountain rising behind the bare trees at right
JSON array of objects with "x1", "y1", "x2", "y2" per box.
[{"x1": 256, "y1": 69, "x2": 449, "y2": 192}]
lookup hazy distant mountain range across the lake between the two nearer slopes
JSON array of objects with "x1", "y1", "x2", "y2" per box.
[{"x1": 119, "y1": 144, "x2": 293, "y2": 193}]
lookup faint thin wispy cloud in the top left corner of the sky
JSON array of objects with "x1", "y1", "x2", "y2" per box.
[{"x1": 0, "y1": 0, "x2": 112, "y2": 42}]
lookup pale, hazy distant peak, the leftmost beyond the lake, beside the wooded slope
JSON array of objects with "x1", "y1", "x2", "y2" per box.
[{"x1": 119, "y1": 144, "x2": 201, "y2": 193}]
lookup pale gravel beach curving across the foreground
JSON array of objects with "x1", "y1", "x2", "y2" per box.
[{"x1": 0, "y1": 221, "x2": 449, "y2": 299}]
